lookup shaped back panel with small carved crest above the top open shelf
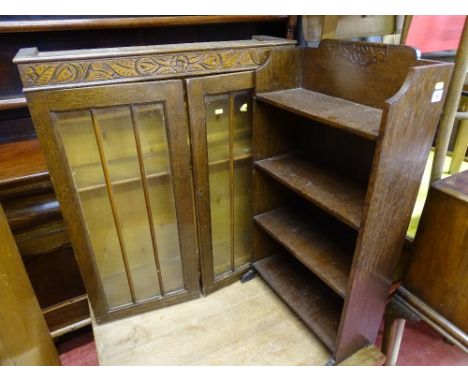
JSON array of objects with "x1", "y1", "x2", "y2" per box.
[{"x1": 302, "y1": 40, "x2": 417, "y2": 108}]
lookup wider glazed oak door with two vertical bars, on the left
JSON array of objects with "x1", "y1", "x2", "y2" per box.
[{"x1": 28, "y1": 80, "x2": 199, "y2": 322}]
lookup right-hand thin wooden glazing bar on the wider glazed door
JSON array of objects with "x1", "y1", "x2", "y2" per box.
[{"x1": 130, "y1": 105, "x2": 165, "y2": 296}]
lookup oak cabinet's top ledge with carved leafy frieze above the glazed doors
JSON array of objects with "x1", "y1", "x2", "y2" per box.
[{"x1": 13, "y1": 36, "x2": 296, "y2": 92}]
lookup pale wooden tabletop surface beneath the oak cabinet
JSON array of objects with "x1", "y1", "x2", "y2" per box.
[{"x1": 93, "y1": 277, "x2": 331, "y2": 365}]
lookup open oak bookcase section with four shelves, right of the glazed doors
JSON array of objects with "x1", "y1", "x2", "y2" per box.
[{"x1": 253, "y1": 40, "x2": 451, "y2": 362}]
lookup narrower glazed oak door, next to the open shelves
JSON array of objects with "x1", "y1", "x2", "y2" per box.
[{"x1": 186, "y1": 72, "x2": 254, "y2": 293}]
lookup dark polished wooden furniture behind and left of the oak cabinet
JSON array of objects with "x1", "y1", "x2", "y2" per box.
[{"x1": 0, "y1": 16, "x2": 294, "y2": 336}]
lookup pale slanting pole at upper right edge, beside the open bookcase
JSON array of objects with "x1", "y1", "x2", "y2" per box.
[{"x1": 431, "y1": 17, "x2": 468, "y2": 182}]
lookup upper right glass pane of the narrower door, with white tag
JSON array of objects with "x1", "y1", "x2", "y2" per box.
[{"x1": 233, "y1": 90, "x2": 252, "y2": 158}]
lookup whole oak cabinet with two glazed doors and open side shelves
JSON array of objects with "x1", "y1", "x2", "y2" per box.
[{"x1": 15, "y1": 37, "x2": 451, "y2": 362}]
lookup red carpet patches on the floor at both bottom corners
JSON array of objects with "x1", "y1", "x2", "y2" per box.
[{"x1": 56, "y1": 321, "x2": 468, "y2": 366}]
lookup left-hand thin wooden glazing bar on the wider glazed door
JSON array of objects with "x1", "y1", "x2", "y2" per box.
[{"x1": 91, "y1": 109, "x2": 137, "y2": 303}]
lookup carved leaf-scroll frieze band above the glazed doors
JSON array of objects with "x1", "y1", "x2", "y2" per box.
[{"x1": 20, "y1": 49, "x2": 270, "y2": 87}]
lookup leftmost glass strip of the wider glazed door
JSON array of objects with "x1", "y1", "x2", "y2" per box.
[{"x1": 55, "y1": 111, "x2": 132, "y2": 308}]
